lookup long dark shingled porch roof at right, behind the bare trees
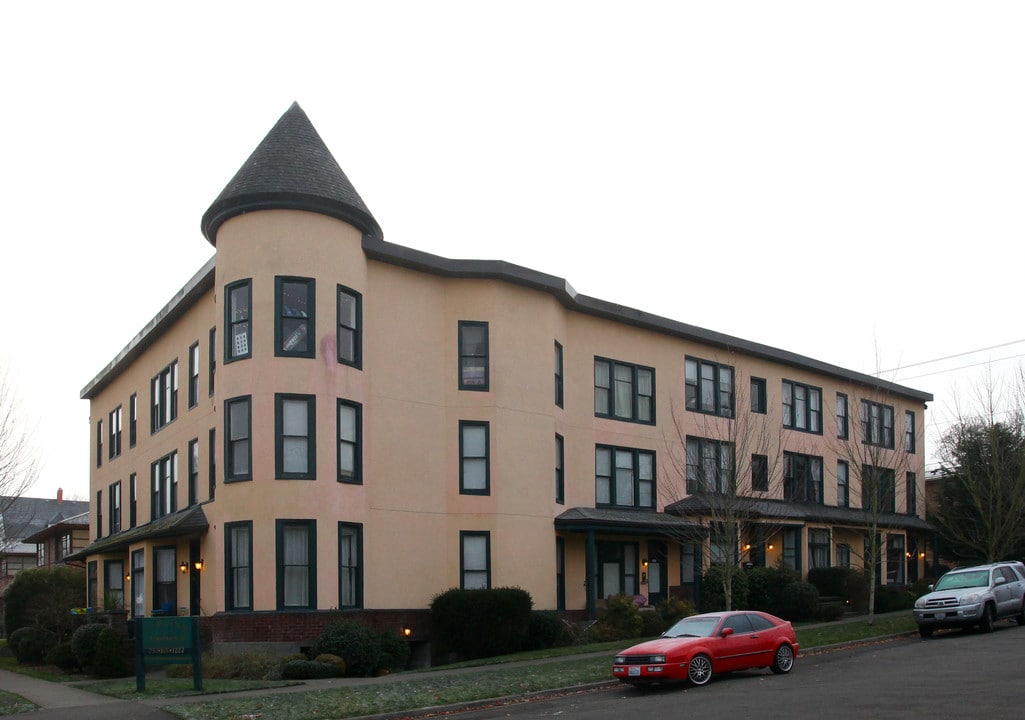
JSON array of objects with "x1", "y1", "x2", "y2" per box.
[{"x1": 665, "y1": 495, "x2": 936, "y2": 532}]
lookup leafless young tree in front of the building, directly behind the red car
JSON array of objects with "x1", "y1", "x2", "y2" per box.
[{"x1": 660, "y1": 365, "x2": 783, "y2": 609}]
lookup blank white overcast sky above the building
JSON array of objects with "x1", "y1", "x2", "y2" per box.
[{"x1": 0, "y1": 0, "x2": 1025, "y2": 498}]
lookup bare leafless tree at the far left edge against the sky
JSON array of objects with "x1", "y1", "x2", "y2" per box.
[{"x1": 0, "y1": 367, "x2": 42, "y2": 521}]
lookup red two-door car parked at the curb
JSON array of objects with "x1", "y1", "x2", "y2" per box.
[{"x1": 612, "y1": 610, "x2": 797, "y2": 685}]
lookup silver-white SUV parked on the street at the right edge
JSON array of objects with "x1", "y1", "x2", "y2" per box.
[{"x1": 914, "y1": 562, "x2": 1025, "y2": 638}]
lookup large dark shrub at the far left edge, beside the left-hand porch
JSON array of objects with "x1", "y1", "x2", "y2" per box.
[{"x1": 3, "y1": 565, "x2": 85, "y2": 642}]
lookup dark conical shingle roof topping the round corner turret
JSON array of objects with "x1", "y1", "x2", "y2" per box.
[{"x1": 201, "y1": 103, "x2": 381, "y2": 245}]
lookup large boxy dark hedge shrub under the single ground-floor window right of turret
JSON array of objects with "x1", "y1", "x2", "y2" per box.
[{"x1": 431, "y1": 588, "x2": 533, "y2": 659}]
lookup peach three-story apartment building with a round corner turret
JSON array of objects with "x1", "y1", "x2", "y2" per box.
[{"x1": 74, "y1": 105, "x2": 932, "y2": 646}]
